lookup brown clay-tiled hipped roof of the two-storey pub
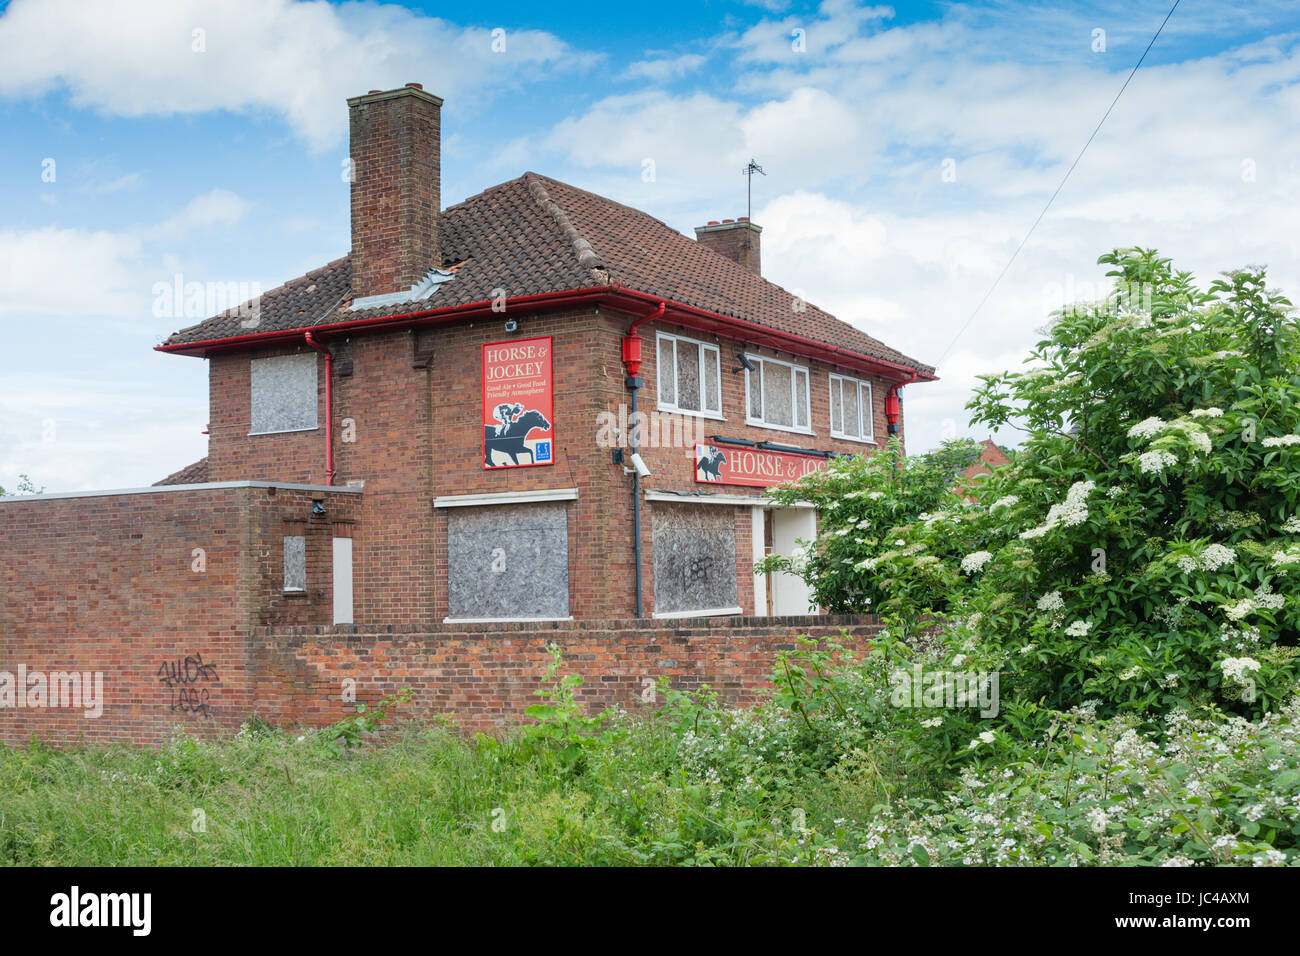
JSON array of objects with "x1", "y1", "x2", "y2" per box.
[{"x1": 164, "y1": 173, "x2": 933, "y2": 375}]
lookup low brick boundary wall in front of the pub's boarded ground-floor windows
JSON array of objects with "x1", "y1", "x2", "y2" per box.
[{"x1": 252, "y1": 615, "x2": 880, "y2": 732}]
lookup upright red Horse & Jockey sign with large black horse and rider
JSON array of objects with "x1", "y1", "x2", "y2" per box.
[{"x1": 482, "y1": 336, "x2": 555, "y2": 468}]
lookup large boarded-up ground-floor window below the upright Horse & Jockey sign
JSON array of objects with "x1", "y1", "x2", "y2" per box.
[{"x1": 447, "y1": 502, "x2": 569, "y2": 619}]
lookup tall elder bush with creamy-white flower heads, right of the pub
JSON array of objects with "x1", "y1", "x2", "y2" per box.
[{"x1": 790, "y1": 250, "x2": 1300, "y2": 717}]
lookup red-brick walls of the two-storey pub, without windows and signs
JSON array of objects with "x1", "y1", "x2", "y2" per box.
[{"x1": 202, "y1": 303, "x2": 909, "y2": 627}]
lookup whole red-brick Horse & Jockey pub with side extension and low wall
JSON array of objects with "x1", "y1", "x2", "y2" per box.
[{"x1": 0, "y1": 83, "x2": 935, "y2": 741}]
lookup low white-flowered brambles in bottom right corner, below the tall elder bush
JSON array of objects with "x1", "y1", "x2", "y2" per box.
[{"x1": 849, "y1": 698, "x2": 1300, "y2": 866}]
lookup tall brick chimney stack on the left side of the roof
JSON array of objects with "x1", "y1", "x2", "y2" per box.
[{"x1": 347, "y1": 83, "x2": 442, "y2": 298}]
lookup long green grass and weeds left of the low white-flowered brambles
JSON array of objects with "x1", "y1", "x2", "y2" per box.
[{"x1": 0, "y1": 719, "x2": 909, "y2": 866}]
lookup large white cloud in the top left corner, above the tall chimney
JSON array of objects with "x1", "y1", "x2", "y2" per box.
[{"x1": 0, "y1": 0, "x2": 593, "y2": 150}]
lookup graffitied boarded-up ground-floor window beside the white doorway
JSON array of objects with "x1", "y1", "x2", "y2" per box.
[{"x1": 653, "y1": 503, "x2": 740, "y2": 614}]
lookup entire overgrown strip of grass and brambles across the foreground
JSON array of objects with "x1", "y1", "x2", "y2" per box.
[{"x1": 0, "y1": 636, "x2": 1300, "y2": 866}]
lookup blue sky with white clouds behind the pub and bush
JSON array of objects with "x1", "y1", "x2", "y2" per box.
[{"x1": 0, "y1": 0, "x2": 1300, "y2": 490}]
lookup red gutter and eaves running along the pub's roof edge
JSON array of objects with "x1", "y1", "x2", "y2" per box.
[{"x1": 155, "y1": 286, "x2": 937, "y2": 382}]
